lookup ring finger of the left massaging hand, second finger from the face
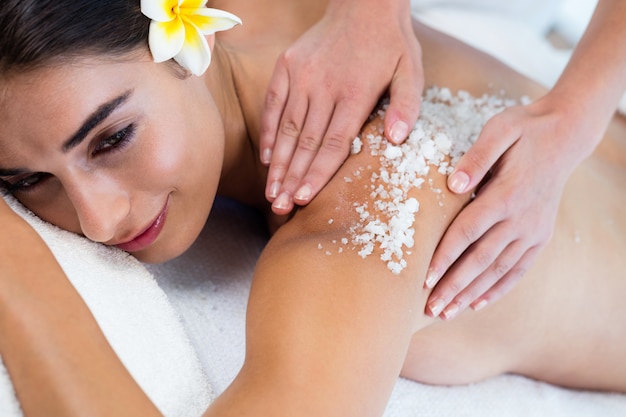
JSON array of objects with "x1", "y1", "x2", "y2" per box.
[{"x1": 265, "y1": 94, "x2": 308, "y2": 205}]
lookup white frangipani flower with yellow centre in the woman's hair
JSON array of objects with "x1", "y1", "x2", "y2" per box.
[{"x1": 141, "y1": 0, "x2": 241, "y2": 76}]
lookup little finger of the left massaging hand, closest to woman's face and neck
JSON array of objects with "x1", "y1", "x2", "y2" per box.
[{"x1": 259, "y1": 59, "x2": 289, "y2": 165}]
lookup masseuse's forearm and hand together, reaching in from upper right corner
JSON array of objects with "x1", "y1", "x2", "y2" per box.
[{"x1": 427, "y1": 0, "x2": 626, "y2": 319}]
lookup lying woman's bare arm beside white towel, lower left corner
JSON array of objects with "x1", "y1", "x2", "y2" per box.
[{"x1": 0, "y1": 199, "x2": 159, "y2": 417}]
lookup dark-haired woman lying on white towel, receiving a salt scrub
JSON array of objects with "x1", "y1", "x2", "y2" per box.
[{"x1": 0, "y1": 0, "x2": 626, "y2": 416}]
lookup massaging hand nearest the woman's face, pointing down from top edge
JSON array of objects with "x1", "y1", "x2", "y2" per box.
[{"x1": 260, "y1": 0, "x2": 423, "y2": 214}]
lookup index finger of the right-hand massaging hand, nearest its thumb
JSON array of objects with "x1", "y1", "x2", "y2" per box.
[{"x1": 424, "y1": 186, "x2": 506, "y2": 288}]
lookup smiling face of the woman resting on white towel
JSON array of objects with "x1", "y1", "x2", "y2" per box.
[{"x1": 0, "y1": 58, "x2": 224, "y2": 262}]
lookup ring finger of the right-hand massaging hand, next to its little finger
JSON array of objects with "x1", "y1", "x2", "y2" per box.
[{"x1": 434, "y1": 240, "x2": 526, "y2": 320}]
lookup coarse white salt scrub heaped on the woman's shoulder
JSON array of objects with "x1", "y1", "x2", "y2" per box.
[{"x1": 342, "y1": 87, "x2": 525, "y2": 274}]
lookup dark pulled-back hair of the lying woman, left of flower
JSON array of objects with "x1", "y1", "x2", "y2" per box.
[{"x1": 0, "y1": 0, "x2": 150, "y2": 75}]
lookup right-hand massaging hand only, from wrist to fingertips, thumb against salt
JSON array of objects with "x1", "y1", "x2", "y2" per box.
[{"x1": 425, "y1": 97, "x2": 603, "y2": 319}]
